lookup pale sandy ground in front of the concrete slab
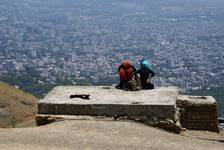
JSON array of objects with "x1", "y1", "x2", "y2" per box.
[{"x1": 0, "y1": 120, "x2": 224, "y2": 150}]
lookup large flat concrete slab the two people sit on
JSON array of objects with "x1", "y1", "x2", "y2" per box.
[{"x1": 37, "y1": 86, "x2": 180, "y2": 131}]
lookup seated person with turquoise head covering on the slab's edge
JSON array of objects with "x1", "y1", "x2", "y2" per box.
[{"x1": 136, "y1": 59, "x2": 155, "y2": 89}]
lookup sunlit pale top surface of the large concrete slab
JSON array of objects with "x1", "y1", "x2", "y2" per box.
[{"x1": 39, "y1": 86, "x2": 178, "y2": 105}]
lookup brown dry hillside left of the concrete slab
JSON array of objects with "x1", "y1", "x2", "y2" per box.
[{"x1": 0, "y1": 82, "x2": 37, "y2": 128}]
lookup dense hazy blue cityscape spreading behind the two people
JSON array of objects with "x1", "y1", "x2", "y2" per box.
[{"x1": 0, "y1": 0, "x2": 224, "y2": 98}]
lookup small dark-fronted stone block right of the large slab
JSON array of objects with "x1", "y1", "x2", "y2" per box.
[{"x1": 177, "y1": 95, "x2": 219, "y2": 132}]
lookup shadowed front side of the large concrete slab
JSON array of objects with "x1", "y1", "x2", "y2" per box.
[{"x1": 36, "y1": 103, "x2": 181, "y2": 132}]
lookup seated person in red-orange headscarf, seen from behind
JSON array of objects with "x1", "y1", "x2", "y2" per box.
[{"x1": 116, "y1": 60, "x2": 139, "y2": 90}]
